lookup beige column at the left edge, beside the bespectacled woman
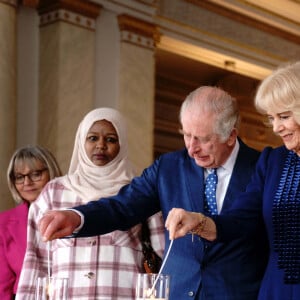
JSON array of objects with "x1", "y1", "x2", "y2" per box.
[{"x1": 0, "y1": 0, "x2": 17, "y2": 211}]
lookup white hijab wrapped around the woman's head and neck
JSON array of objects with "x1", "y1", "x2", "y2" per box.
[{"x1": 61, "y1": 108, "x2": 134, "y2": 202}]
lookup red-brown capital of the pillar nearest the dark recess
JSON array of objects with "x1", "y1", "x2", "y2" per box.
[{"x1": 118, "y1": 14, "x2": 160, "y2": 49}]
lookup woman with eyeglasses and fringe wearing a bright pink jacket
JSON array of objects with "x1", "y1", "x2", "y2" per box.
[{"x1": 0, "y1": 146, "x2": 61, "y2": 300}]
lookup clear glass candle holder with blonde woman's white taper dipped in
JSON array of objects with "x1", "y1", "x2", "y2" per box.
[{"x1": 135, "y1": 273, "x2": 170, "y2": 300}]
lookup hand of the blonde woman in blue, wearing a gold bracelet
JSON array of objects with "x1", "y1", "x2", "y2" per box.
[{"x1": 165, "y1": 208, "x2": 199, "y2": 240}]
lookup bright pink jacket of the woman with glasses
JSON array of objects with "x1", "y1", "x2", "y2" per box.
[{"x1": 0, "y1": 202, "x2": 28, "y2": 300}]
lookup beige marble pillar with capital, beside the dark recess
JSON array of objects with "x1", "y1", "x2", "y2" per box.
[{"x1": 117, "y1": 14, "x2": 159, "y2": 172}]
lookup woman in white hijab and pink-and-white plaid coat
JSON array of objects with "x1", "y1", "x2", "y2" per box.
[{"x1": 17, "y1": 108, "x2": 164, "y2": 300}]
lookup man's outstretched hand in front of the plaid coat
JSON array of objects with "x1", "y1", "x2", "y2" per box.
[{"x1": 38, "y1": 210, "x2": 81, "y2": 242}]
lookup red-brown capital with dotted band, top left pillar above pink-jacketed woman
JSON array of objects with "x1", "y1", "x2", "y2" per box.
[{"x1": 37, "y1": 0, "x2": 102, "y2": 30}]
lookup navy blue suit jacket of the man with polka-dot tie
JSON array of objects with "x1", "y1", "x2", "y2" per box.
[{"x1": 77, "y1": 141, "x2": 267, "y2": 300}]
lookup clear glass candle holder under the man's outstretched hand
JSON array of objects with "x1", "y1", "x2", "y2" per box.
[{"x1": 35, "y1": 277, "x2": 68, "y2": 300}]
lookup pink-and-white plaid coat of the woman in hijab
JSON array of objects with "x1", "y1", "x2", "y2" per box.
[{"x1": 16, "y1": 178, "x2": 164, "y2": 300}]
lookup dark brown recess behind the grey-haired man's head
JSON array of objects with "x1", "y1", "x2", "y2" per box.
[{"x1": 154, "y1": 49, "x2": 281, "y2": 158}]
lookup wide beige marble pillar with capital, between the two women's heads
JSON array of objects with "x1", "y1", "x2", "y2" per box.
[{"x1": 38, "y1": 0, "x2": 101, "y2": 172}]
